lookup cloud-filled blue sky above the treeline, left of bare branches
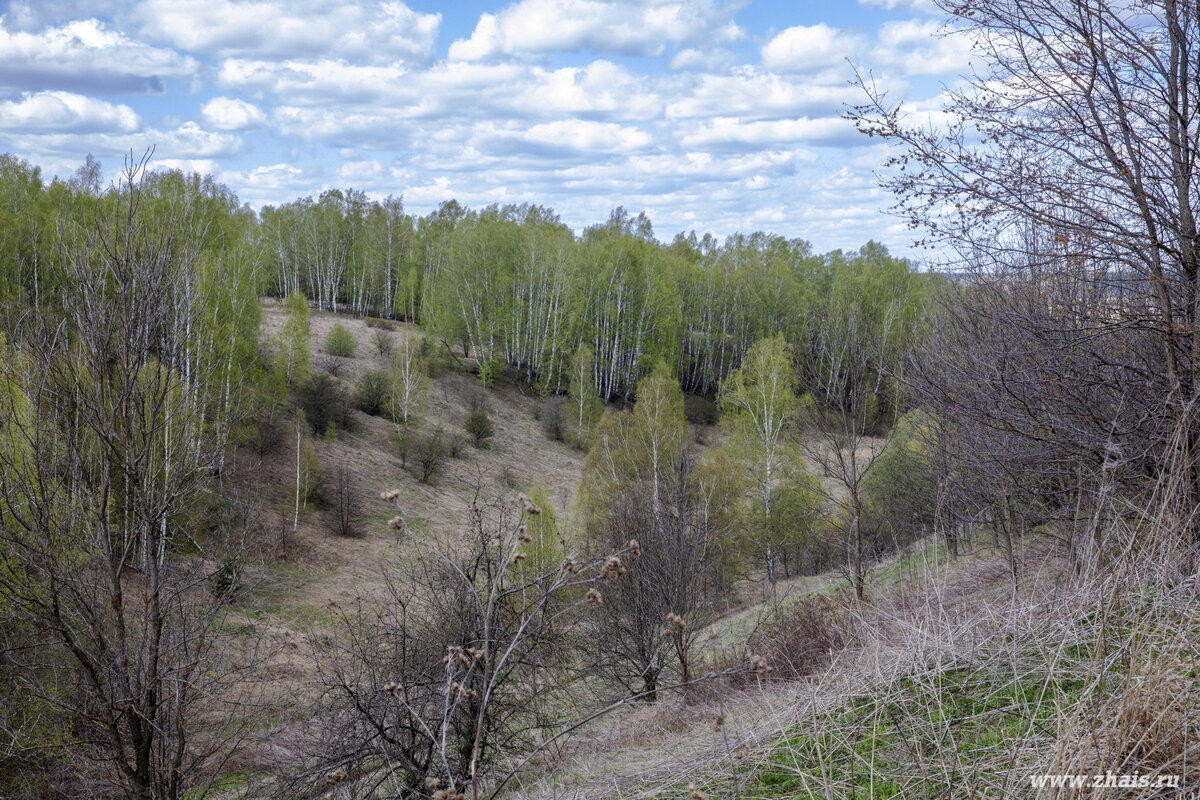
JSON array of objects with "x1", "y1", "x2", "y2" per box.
[{"x1": 0, "y1": 0, "x2": 970, "y2": 252}]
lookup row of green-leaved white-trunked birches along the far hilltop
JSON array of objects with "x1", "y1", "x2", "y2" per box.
[{"x1": 0, "y1": 157, "x2": 932, "y2": 401}]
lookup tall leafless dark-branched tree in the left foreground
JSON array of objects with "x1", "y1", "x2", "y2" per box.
[{"x1": 0, "y1": 153, "x2": 260, "y2": 800}]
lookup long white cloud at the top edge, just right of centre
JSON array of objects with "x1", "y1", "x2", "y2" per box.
[{"x1": 450, "y1": 0, "x2": 744, "y2": 61}]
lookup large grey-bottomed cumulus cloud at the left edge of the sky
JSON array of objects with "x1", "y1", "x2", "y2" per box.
[{"x1": 0, "y1": 17, "x2": 196, "y2": 95}]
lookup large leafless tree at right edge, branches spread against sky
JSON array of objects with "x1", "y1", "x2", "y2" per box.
[{"x1": 854, "y1": 0, "x2": 1200, "y2": 534}]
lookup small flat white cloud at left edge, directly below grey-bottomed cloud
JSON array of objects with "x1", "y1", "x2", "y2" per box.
[{"x1": 0, "y1": 91, "x2": 142, "y2": 133}]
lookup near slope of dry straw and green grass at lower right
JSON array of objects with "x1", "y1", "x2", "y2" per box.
[{"x1": 508, "y1": 527, "x2": 1200, "y2": 800}]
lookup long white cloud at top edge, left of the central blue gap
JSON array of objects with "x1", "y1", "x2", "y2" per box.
[{"x1": 139, "y1": 0, "x2": 442, "y2": 64}]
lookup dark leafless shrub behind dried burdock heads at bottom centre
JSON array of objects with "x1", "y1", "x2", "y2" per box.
[{"x1": 292, "y1": 492, "x2": 667, "y2": 798}]
